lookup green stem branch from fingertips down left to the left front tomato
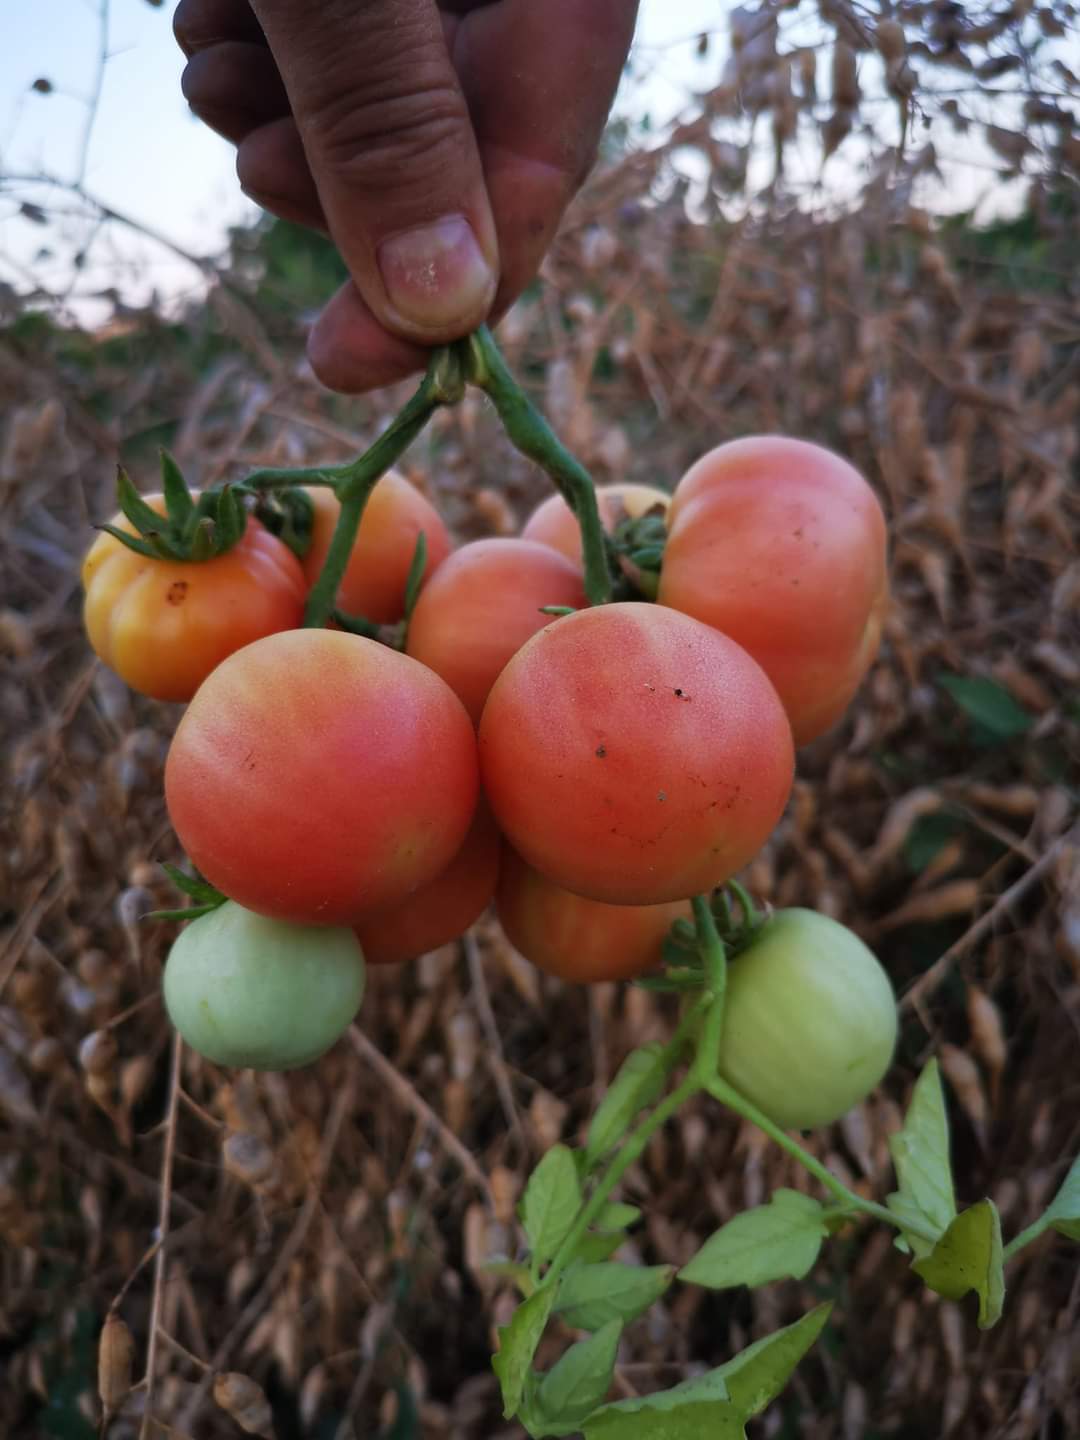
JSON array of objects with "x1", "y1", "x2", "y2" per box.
[{"x1": 300, "y1": 346, "x2": 464, "y2": 626}]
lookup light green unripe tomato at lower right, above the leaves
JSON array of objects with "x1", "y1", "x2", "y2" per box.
[{"x1": 720, "y1": 910, "x2": 897, "y2": 1130}]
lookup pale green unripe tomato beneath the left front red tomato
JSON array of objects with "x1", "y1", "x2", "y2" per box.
[{"x1": 164, "y1": 900, "x2": 364, "y2": 1070}]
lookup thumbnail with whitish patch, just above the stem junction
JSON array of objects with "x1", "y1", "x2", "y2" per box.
[{"x1": 379, "y1": 215, "x2": 495, "y2": 330}]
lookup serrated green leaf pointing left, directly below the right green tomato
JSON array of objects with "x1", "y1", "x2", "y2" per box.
[{"x1": 678, "y1": 1189, "x2": 828, "y2": 1290}]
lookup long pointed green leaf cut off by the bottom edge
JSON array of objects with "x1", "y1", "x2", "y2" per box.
[{"x1": 582, "y1": 1305, "x2": 832, "y2": 1440}]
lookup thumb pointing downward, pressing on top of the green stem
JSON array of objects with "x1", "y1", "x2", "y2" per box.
[{"x1": 249, "y1": 0, "x2": 498, "y2": 344}]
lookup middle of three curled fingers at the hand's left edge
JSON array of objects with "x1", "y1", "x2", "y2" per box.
[{"x1": 180, "y1": 40, "x2": 289, "y2": 145}]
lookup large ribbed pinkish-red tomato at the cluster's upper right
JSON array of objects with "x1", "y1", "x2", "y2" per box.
[{"x1": 658, "y1": 435, "x2": 887, "y2": 744}]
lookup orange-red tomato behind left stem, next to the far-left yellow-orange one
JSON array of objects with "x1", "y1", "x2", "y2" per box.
[{"x1": 304, "y1": 471, "x2": 451, "y2": 625}]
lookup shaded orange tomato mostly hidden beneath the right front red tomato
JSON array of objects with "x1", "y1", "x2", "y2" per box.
[{"x1": 495, "y1": 845, "x2": 691, "y2": 984}]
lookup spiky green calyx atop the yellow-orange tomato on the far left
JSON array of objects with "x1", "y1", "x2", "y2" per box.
[{"x1": 98, "y1": 449, "x2": 248, "y2": 563}]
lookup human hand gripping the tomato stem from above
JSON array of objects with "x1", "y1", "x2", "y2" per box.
[{"x1": 174, "y1": 0, "x2": 638, "y2": 392}]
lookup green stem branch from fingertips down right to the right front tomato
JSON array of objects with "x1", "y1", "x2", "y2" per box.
[{"x1": 462, "y1": 325, "x2": 612, "y2": 605}]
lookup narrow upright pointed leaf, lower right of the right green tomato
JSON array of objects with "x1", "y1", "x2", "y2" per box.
[{"x1": 886, "y1": 1060, "x2": 956, "y2": 1256}]
